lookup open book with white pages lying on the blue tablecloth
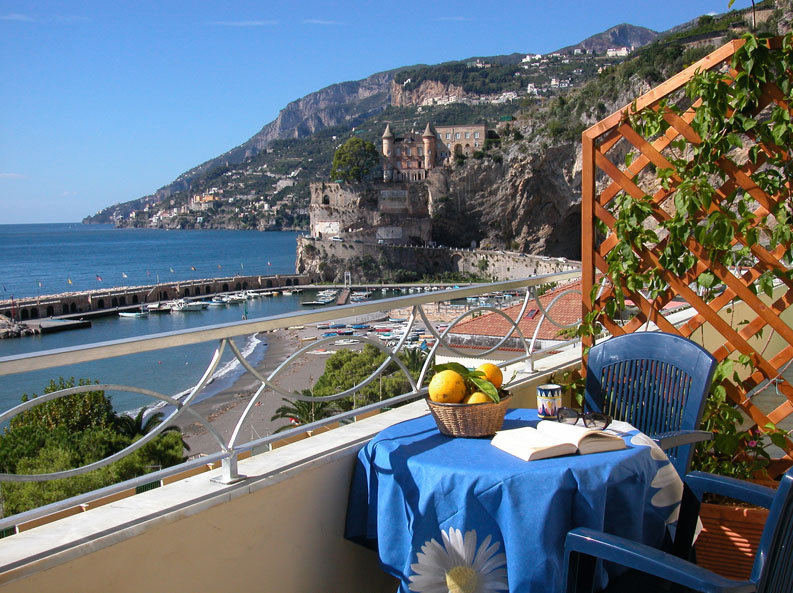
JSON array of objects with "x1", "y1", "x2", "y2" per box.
[{"x1": 490, "y1": 420, "x2": 625, "y2": 461}]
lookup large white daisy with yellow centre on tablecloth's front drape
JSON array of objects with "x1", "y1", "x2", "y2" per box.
[{"x1": 409, "y1": 527, "x2": 509, "y2": 593}]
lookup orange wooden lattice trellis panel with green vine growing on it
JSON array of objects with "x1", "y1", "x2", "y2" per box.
[{"x1": 581, "y1": 39, "x2": 793, "y2": 473}]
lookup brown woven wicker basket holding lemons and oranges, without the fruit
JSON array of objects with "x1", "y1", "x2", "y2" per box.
[{"x1": 427, "y1": 393, "x2": 512, "y2": 437}]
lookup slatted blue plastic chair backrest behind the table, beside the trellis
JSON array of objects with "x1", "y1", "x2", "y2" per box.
[{"x1": 584, "y1": 332, "x2": 716, "y2": 477}]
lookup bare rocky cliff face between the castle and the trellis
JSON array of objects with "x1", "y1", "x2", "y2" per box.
[{"x1": 429, "y1": 77, "x2": 650, "y2": 260}]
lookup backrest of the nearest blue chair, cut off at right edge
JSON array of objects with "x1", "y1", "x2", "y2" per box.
[{"x1": 750, "y1": 469, "x2": 793, "y2": 593}]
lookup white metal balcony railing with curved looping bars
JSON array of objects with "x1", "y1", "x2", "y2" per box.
[{"x1": 0, "y1": 270, "x2": 580, "y2": 530}]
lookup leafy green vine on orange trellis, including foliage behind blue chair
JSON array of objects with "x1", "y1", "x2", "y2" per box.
[{"x1": 579, "y1": 35, "x2": 793, "y2": 476}]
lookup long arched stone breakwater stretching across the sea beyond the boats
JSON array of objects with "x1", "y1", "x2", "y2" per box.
[{"x1": 0, "y1": 274, "x2": 310, "y2": 323}]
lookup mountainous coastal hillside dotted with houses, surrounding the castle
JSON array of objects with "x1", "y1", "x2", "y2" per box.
[{"x1": 85, "y1": 2, "x2": 776, "y2": 259}]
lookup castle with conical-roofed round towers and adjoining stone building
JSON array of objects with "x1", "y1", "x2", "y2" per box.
[{"x1": 382, "y1": 123, "x2": 487, "y2": 181}]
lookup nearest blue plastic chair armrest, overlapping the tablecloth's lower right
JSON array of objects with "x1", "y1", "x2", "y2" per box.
[{"x1": 564, "y1": 527, "x2": 756, "y2": 593}]
